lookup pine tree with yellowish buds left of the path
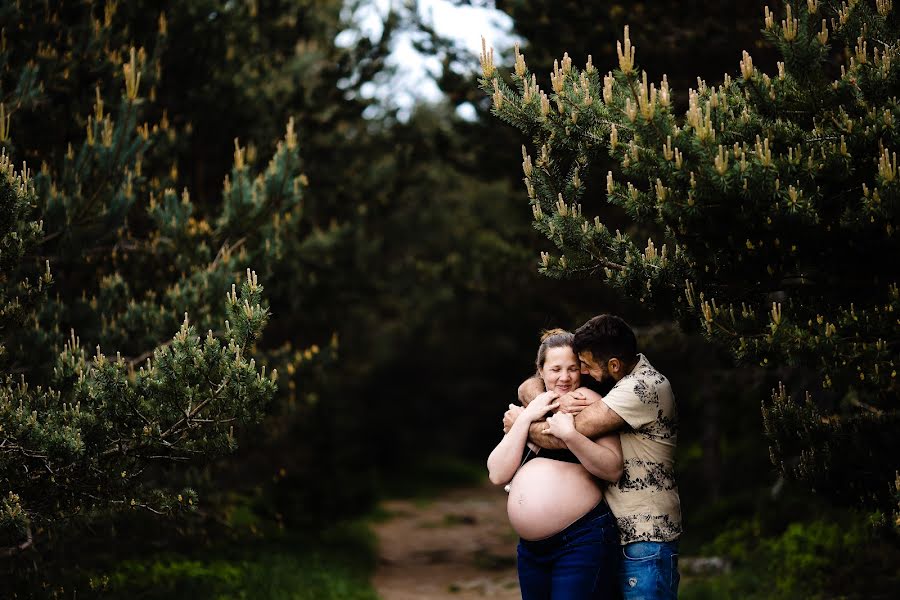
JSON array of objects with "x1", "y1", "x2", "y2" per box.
[{"x1": 0, "y1": 2, "x2": 344, "y2": 554}]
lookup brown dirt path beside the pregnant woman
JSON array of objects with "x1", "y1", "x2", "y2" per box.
[{"x1": 374, "y1": 484, "x2": 520, "y2": 600}]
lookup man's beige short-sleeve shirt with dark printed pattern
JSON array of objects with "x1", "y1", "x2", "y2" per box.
[{"x1": 603, "y1": 354, "x2": 681, "y2": 544}]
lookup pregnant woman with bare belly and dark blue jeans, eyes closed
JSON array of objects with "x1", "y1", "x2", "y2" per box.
[{"x1": 488, "y1": 329, "x2": 622, "y2": 600}]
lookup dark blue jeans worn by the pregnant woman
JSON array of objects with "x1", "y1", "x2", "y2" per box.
[{"x1": 518, "y1": 502, "x2": 620, "y2": 600}]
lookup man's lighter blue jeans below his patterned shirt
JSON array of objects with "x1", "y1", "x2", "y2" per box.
[{"x1": 619, "y1": 541, "x2": 680, "y2": 600}]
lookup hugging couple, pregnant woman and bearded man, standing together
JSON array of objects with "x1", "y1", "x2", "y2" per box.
[{"x1": 488, "y1": 315, "x2": 681, "y2": 600}]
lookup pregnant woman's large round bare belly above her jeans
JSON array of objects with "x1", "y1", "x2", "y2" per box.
[{"x1": 506, "y1": 458, "x2": 603, "y2": 540}]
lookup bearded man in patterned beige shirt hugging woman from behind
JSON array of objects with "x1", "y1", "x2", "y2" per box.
[{"x1": 503, "y1": 315, "x2": 681, "y2": 600}]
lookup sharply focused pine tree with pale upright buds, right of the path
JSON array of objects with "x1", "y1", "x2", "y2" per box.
[{"x1": 481, "y1": 0, "x2": 900, "y2": 510}]
